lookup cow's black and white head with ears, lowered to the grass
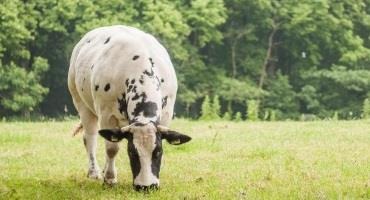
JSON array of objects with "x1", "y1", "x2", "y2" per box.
[{"x1": 99, "y1": 122, "x2": 191, "y2": 190}]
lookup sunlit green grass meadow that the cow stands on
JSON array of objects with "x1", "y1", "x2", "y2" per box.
[{"x1": 0, "y1": 120, "x2": 370, "y2": 199}]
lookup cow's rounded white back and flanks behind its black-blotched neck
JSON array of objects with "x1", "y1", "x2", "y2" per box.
[{"x1": 68, "y1": 26, "x2": 177, "y2": 126}]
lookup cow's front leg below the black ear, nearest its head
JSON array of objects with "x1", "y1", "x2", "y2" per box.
[{"x1": 104, "y1": 141, "x2": 119, "y2": 185}]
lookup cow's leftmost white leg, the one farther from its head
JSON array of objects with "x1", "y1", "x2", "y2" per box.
[{"x1": 79, "y1": 108, "x2": 101, "y2": 179}]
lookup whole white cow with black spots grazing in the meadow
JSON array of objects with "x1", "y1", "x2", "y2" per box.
[{"x1": 68, "y1": 26, "x2": 191, "y2": 190}]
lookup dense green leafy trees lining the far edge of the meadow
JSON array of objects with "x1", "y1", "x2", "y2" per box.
[{"x1": 0, "y1": 0, "x2": 370, "y2": 120}]
